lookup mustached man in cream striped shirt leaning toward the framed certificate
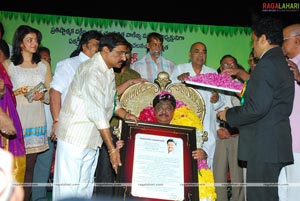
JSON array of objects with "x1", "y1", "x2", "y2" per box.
[{"x1": 53, "y1": 32, "x2": 137, "y2": 200}]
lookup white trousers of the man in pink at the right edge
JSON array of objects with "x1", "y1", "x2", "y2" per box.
[{"x1": 278, "y1": 152, "x2": 300, "y2": 201}]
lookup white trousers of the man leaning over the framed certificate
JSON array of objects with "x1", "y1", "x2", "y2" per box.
[{"x1": 53, "y1": 140, "x2": 99, "y2": 201}]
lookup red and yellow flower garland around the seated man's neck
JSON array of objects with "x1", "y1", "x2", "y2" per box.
[{"x1": 139, "y1": 92, "x2": 217, "y2": 201}]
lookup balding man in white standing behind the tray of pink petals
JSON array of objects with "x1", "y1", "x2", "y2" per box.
[{"x1": 170, "y1": 42, "x2": 225, "y2": 169}]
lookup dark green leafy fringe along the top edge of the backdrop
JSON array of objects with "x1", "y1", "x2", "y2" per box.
[{"x1": 0, "y1": 11, "x2": 251, "y2": 37}]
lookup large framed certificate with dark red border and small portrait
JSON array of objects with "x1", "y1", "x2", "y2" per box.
[{"x1": 117, "y1": 121, "x2": 199, "y2": 201}]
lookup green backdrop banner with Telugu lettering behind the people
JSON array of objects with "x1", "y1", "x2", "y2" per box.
[{"x1": 0, "y1": 11, "x2": 251, "y2": 70}]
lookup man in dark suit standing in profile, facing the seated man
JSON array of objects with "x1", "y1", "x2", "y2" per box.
[{"x1": 217, "y1": 18, "x2": 294, "y2": 201}]
